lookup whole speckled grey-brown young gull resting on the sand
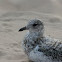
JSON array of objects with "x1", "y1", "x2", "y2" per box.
[{"x1": 19, "y1": 19, "x2": 62, "y2": 62}]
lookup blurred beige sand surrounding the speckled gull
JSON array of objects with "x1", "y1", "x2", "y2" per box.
[{"x1": 0, "y1": 0, "x2": 62, "y2": 62}]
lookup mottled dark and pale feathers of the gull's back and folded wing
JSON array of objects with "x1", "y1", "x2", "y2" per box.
[{"x1": 38, "y1": 37, "x2": 62, "y2": 60}]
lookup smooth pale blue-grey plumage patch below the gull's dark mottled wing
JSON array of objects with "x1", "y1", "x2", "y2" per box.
[{"x1": 29, "y1": 46, "x2": 52, "y2": 62}]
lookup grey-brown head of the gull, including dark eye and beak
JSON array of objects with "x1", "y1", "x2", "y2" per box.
[{"x1": 19, "y1": 19, "x2": 44, "y2": 32}]
